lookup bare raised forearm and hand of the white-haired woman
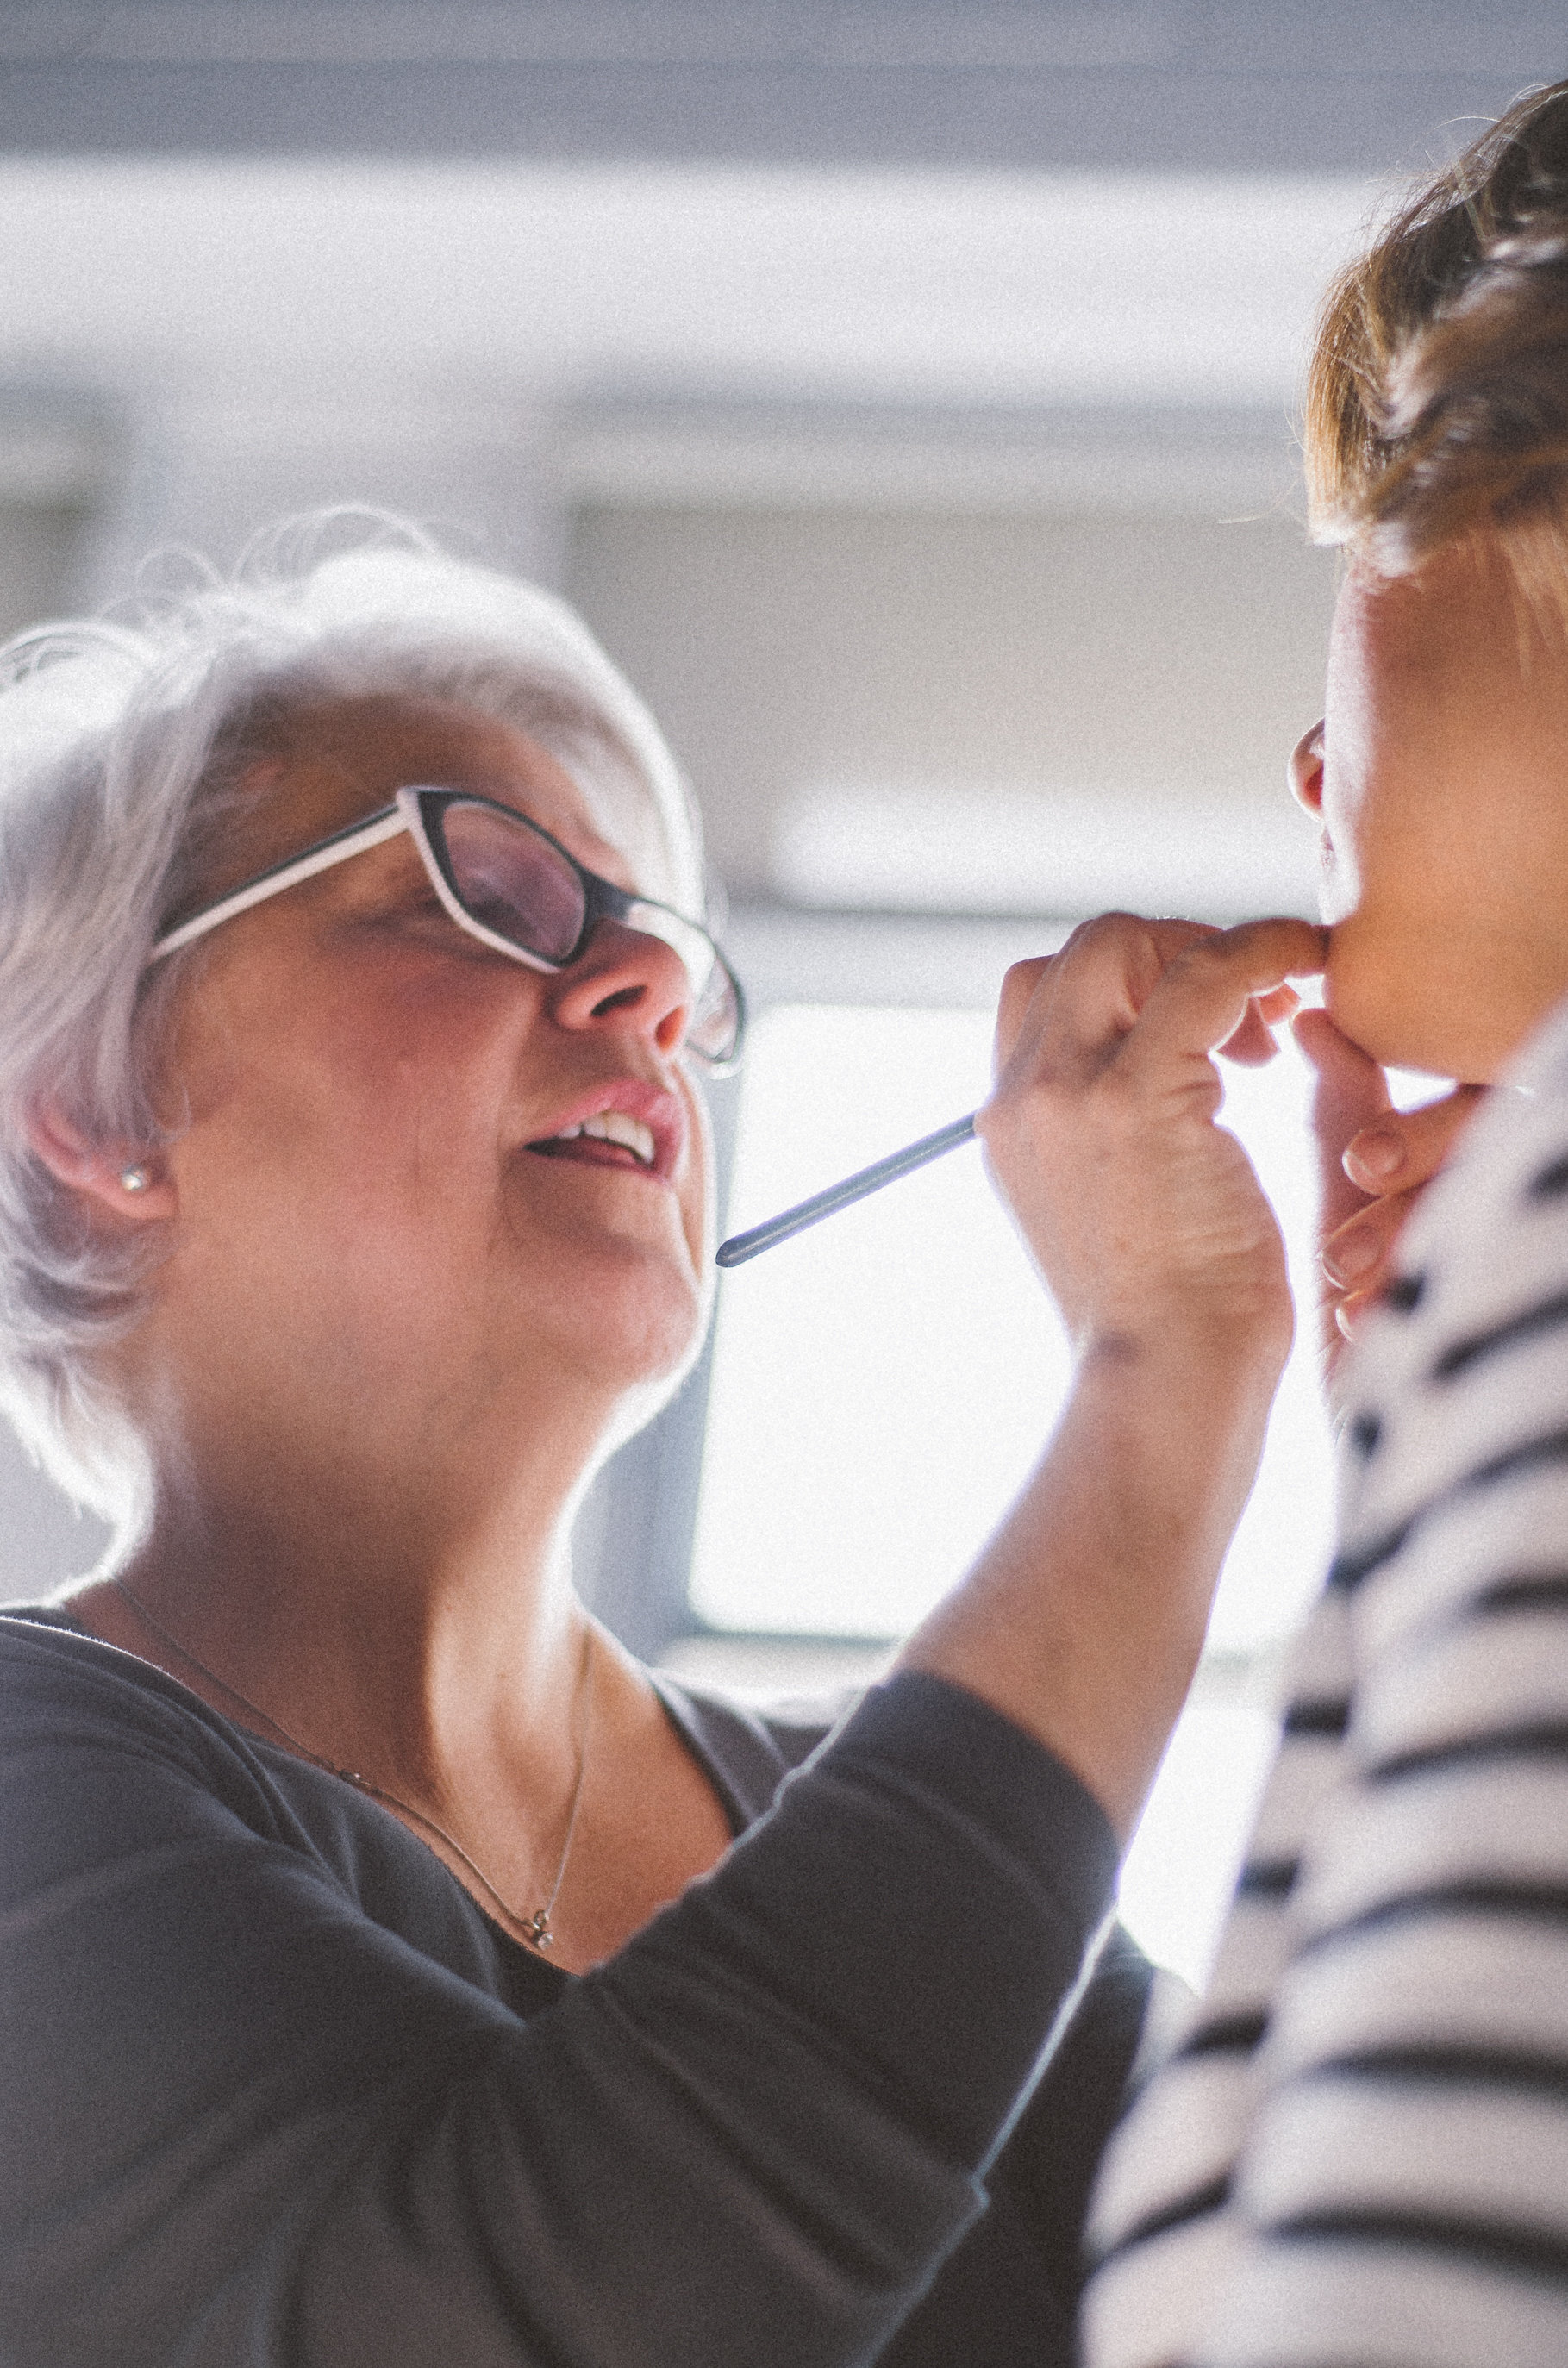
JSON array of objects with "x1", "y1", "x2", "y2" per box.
[{"x1": 905, "y1": 914, "x2": 1324, "y2": 1840}]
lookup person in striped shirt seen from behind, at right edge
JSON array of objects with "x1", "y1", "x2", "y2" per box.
[{"x1": 1087, "y1": 83, "x2": 1568, "y2": 2368}]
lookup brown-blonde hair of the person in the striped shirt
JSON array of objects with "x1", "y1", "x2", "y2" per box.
[{"x1": 1305, "y1": 83, "x2": 1568, "y2": 625}]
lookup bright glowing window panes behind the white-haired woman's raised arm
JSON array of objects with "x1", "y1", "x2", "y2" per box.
[{"x1": 691, "y1": 1004, "x2": 1334, "y2": 1982}]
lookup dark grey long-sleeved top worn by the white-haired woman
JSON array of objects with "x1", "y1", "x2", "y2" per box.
[{"x1": 0, "y1": 1610, "x2": 1149, "y2": 2368}]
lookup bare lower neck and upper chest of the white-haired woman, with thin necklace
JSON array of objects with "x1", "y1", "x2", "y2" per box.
[{"x1": 71, "y1": 1430, "x2": 729, "y2": 1971}]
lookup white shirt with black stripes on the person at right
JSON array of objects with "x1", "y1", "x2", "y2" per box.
[{"x1": 1084, "y1": 994, "x2": 1568, "y2": 2368}]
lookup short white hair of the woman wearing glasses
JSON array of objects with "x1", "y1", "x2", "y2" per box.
[{"x1": 0, "y1": 511, "x2": 703, "y2": 1532}]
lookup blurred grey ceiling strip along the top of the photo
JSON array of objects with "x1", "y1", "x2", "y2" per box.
[{"x1": 0, "y1": 0, "x2": 1568, "y2": 173}]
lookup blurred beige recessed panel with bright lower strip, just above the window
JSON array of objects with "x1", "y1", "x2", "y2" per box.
[{"x1": 566, "y1": 497, "x2": 1336, "y2": 916}]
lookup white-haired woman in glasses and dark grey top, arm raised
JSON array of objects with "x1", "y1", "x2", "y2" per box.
[{"x1": 0, "y1": 521, "x2": 1319, "y2": 2368}]
